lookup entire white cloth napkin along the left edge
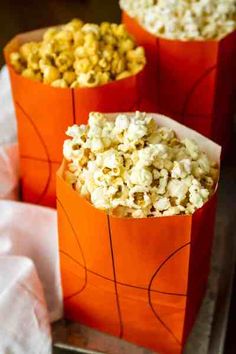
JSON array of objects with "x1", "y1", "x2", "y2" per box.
[{"x1": 0, "y1": 68, "x2": 62, "y2": 354}]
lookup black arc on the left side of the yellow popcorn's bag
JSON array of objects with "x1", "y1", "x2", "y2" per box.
[{"x1": 16, "y1": 102, "x2": 52, "y2": 204}]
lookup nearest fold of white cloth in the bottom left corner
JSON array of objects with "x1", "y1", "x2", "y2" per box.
[{"x1": 0, "y1": 256, "x2": 52, "y2": 354}]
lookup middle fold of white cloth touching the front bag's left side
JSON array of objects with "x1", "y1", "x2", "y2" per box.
[{"x1": 0, "y1": 201, "x2": 62, "y2": 323}]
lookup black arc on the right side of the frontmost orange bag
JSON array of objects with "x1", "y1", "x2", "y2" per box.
[{"x1": 148, "y1": 242, "x2": 190, "y2": 345}]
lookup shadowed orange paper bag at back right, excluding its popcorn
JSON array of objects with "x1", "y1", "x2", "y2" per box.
[{"x1": 123, "y1": 12, "x2": 236, "y2": 150}]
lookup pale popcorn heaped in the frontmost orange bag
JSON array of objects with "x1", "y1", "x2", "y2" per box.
[{"x1": 63, "y1": 112, "x2": 219, "y2": 218}]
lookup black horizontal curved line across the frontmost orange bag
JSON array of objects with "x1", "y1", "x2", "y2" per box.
[{"x1": 59, "y1": 250, "x2": 186, "y2": 296}]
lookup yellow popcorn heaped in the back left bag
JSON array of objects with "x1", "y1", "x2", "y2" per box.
[{"x1": 10, "y1": 19, "x2": 146, "y2": 88}]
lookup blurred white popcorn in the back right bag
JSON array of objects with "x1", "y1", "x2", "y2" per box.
[{"x1": 120, "y1": 0, "x2": 236, "y2": 40}]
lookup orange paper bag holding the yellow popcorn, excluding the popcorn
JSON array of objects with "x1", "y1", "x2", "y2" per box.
[{"x1": 5, "y1": 30, "x2": 150, "y2": 207}]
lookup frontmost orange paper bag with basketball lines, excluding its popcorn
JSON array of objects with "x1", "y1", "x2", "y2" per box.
[{"x1": 57, "y1": 115, "x2": 220, "y2": 354}]
